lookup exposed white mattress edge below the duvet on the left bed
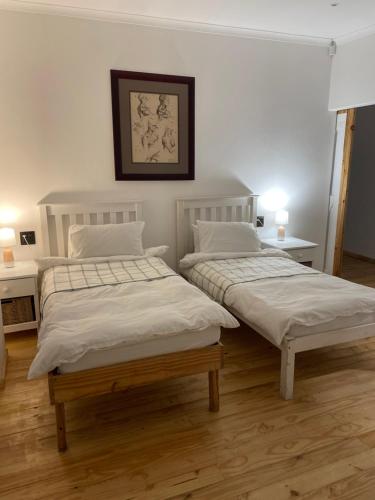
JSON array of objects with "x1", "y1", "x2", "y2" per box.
[{"x1": 59, "y1": 326, "x2": 220, "y2": 373}]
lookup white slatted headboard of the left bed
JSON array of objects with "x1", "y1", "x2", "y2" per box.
[{"x1": 40, "y1": 201, "x2": 142, "y2": 257}]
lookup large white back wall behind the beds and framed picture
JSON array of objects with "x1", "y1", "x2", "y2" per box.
[{"x1": 0, "y1": 12, "x2": 334, "y2": 270}]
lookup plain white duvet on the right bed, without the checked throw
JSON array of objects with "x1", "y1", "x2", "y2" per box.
[{"x1": 181, "y1": 250, "x2": 375, "y2": 345}]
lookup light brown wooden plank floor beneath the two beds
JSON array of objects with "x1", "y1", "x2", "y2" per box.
[{"x1": 0, "y1": 264, "x2": 375, "y2": 500}]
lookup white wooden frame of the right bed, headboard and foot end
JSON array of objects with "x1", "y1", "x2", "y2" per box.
[{"x1": 177, "y1": 195, "x2": 375, "y2": 399}]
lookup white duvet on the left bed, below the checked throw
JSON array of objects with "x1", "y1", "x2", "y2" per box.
[{"x1": 28, "y1": 262, "x2": 238, "y2": 379}]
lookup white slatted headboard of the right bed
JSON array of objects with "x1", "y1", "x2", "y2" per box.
[{"x1": 177, "y1": 195, "x2": 258, "y2": 263}]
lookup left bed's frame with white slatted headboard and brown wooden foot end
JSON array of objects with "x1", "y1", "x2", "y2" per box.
[{"x1": 40, "y1": 201, "x2": 223, "y2": 451}]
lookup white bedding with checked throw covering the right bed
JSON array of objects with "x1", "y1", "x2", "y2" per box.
[{"x1": 180, "y1": 251, "x2": 375, "y2": 345}]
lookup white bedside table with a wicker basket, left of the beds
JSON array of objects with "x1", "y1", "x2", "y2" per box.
[{"x1": 0, "y1": 260, "x2": 40, "y2": 333}]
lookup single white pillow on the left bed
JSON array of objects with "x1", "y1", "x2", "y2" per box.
[{"x1": 68, "y1": 222, "x2": 145, "y2": 259}]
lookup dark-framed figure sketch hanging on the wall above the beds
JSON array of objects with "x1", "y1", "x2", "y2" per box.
[{"x1": 111, "y1": 70, "x2": 195, "y2": 181}]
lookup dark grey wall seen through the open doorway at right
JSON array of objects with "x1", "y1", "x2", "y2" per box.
[{"x1": 344, "y1": 106, "x2": 375, "y2": 259}]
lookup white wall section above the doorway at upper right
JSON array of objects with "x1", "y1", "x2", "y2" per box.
[{"x1": 329, "y1": 34, "x2": 375, "y2": 110}]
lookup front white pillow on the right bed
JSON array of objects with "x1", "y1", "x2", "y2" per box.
[{"x1": 197, "y1": 220, "x2": 261, "y2": 253}]
